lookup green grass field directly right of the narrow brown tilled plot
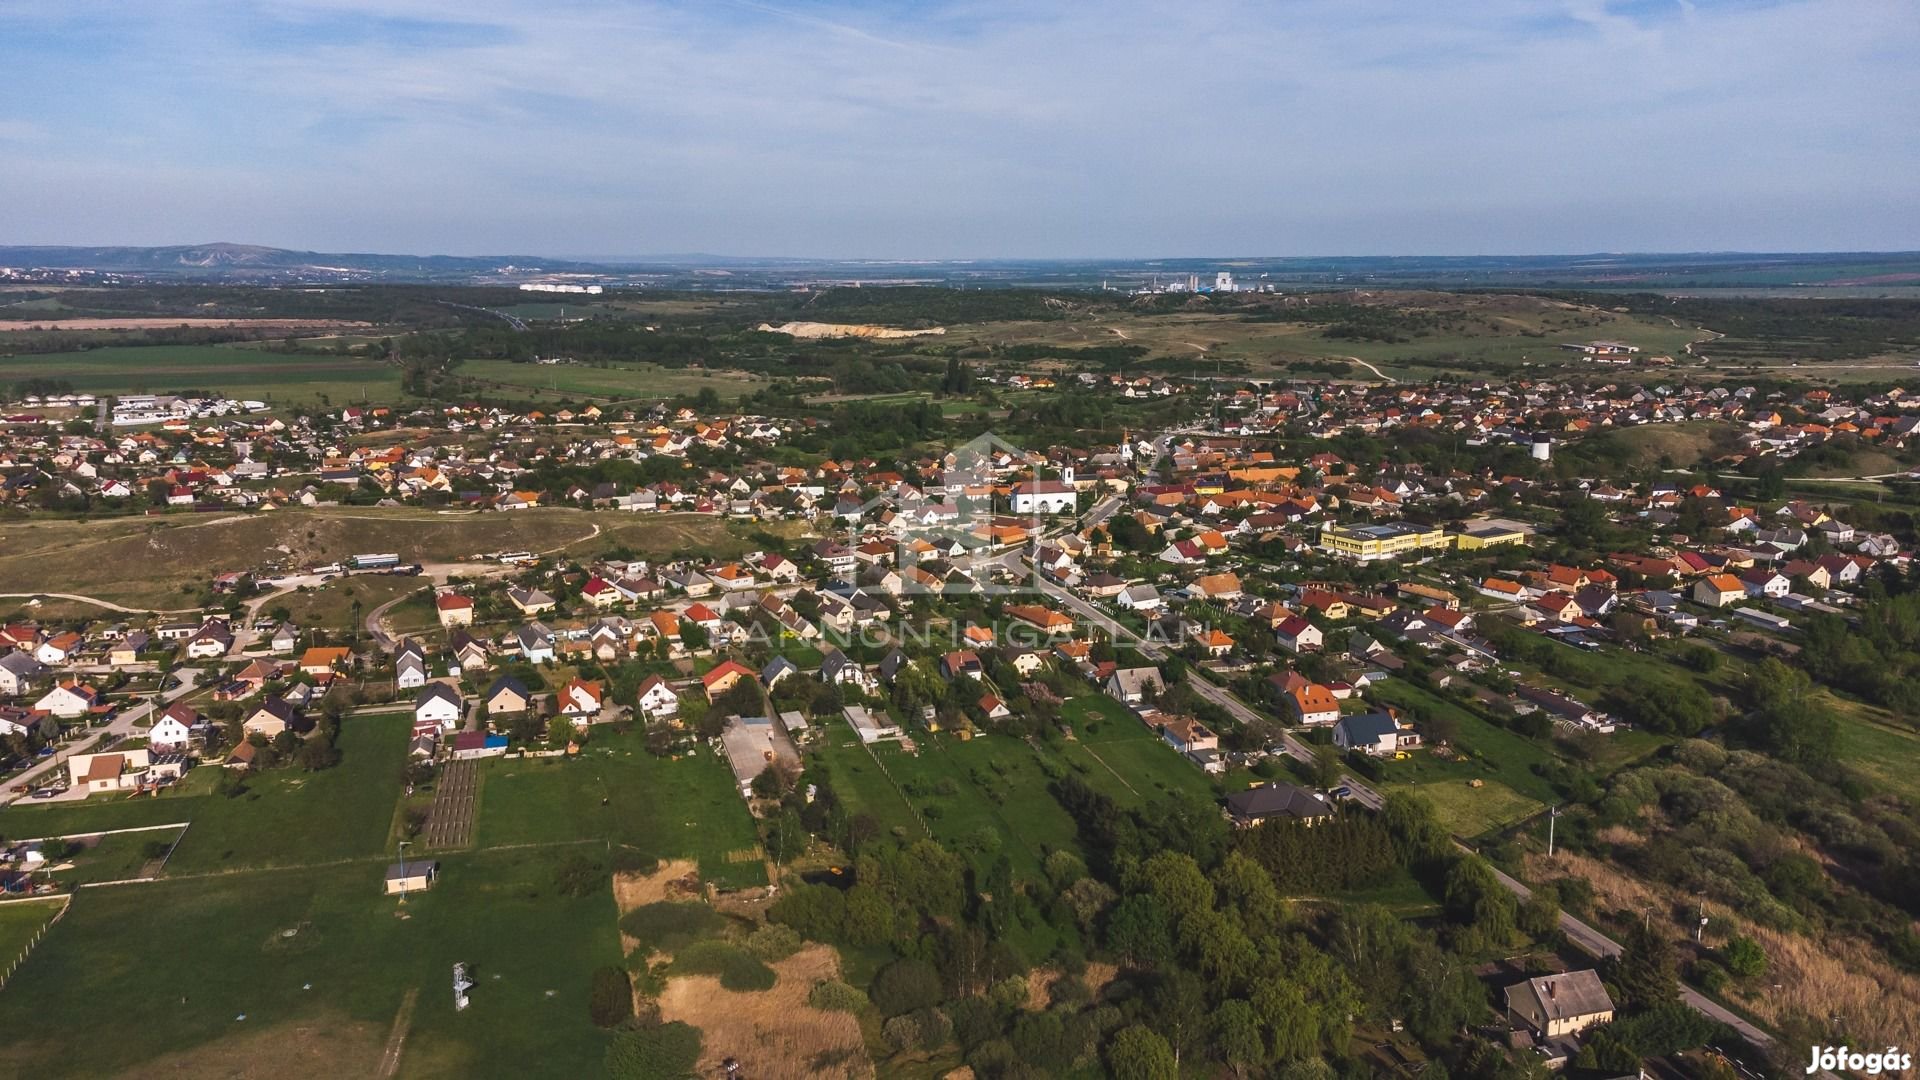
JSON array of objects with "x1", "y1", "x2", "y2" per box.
[{"x1": 474, "y1": 730, "x2": 766, "y2": 888}]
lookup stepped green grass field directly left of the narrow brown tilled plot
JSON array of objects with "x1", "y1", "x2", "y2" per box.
[{"x1": 167, "y1": 713, "x2": 411, "y2": 876}]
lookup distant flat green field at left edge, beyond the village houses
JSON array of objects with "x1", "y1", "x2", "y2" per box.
[{"x1": 0, "y1": 344, "x2": 401, "y2": 404}]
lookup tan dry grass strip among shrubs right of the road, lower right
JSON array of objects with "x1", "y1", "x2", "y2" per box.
[{"x1": 1526, "y1": 851, "x2": 1920, "y2": 1045}]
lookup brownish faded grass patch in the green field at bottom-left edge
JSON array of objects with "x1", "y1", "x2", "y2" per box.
[{"x1": 107, "y1": 1015, "x2": 388, "y2": 1080}]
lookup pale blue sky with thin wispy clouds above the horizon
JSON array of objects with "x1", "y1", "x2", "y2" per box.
[{"x1": 0, "y1": 0, "x2": 1920, "y2": 258}]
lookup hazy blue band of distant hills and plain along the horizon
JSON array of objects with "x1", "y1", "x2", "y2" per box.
[{"x1": 0, "y1": 242, "x2": 1920, "y2": 290}]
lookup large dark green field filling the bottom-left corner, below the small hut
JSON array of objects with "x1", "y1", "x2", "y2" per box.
[{"x1": 0, "y1": 851, "x2": 620, "y2": 1078}]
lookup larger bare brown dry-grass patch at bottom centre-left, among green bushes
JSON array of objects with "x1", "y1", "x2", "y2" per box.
[{"x1": 660, "y1": 945, "x2": 874, "y2": 1080}]
